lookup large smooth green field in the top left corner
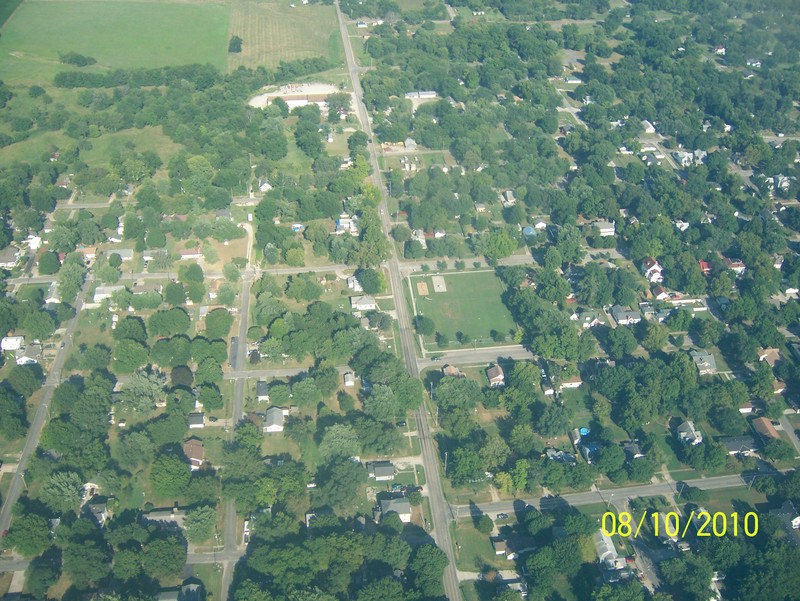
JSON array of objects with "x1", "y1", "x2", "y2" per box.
[{"x1": 0, "y1": 0, "x2": 230, "y2": 85}]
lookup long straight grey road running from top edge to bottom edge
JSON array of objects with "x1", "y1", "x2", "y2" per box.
[{"x1": 336, "y1": 0, "x2": 461, "y2": 601}]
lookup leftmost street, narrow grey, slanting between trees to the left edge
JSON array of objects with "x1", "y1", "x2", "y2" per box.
[{"x1": 0, "y1": 276, "x2": 94, "y2": 532}]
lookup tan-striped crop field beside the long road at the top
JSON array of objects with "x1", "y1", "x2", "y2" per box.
[{"x1": 228, "y1": 0, "x2": 344, "y2": 71}]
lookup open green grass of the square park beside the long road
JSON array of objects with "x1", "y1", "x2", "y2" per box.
[{"x1": 409, "y1": 271, "x2": 516, "y2": 350}]
